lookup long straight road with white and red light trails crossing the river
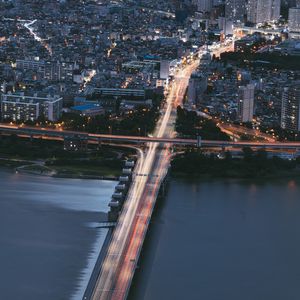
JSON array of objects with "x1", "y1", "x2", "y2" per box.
[{"x1": 92, "y1": 61, "x2": 198, "y2": 300}]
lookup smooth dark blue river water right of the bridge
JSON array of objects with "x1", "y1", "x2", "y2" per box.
[{"x1": 129, "y1": 180, "x2": 300, "y2": 300}]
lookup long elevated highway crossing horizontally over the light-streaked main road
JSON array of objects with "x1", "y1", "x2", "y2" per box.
[{"x1": 0, "y1": 124, "x2": 300, "y2": 149}]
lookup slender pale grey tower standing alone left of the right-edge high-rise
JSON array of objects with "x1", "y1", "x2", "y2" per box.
[{"x1": 238, "y1": 84, "x2": 255, "y2": 123}]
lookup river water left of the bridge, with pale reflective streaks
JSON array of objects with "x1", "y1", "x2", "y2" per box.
[{"x1": 0, "y1": 170, "x2": 115, "y2": 300}]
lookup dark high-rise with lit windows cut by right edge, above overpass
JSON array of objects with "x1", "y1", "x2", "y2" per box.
[{"x1": 281, "y1": 82, "x2": 300, "y2": 131}]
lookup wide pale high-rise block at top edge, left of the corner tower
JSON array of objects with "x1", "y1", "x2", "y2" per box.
[{"x1": 247, "y1": 0, "x2": 281, "y2": 24}]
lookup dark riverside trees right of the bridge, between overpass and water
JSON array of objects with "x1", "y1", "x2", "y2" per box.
[{"x1": 172, "y1": 148, "x2": 299, "y2": 178}]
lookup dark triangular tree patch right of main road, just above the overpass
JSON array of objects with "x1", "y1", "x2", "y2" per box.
[{"x1": 176, "y1": 106, "x2": 230, "y2": 141}]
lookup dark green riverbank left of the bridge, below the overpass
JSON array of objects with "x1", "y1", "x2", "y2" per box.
[{"x1": 0, "y1": 136, "x2": 135, "y2": 180}]
